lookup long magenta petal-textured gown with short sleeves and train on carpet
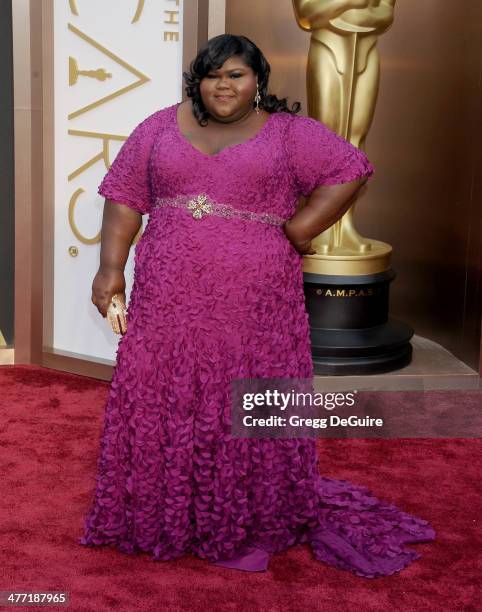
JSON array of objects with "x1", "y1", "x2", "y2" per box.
[{"x1": 79, "y1": 104, "x2": 435, "y2": 577}]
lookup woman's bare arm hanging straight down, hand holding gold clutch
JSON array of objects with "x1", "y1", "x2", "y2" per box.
[{"x1": 91, "y1": 199, "x2": 142, "y2": 317}]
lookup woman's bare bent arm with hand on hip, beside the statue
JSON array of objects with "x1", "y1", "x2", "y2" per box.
[{"x1": 283, "y1": 176, "x2": 368, "y2": 255}]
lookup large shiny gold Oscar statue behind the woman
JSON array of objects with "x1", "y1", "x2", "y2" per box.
[{"x1": 293, "y1": 0, "x2": 395, "y2": 275}]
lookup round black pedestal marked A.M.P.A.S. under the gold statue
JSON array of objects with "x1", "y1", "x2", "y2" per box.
[{"x1": 304, "y1": 268, "x2": 413, "y2": 375}]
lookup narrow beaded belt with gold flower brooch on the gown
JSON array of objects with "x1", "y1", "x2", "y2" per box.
[{"x1": 155, "y1": 193, "x2": 286, "y2": 225}]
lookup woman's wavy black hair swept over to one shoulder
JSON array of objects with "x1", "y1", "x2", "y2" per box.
[{"x1": 182, "y1": 34, "x2": 301, "y2": 126}]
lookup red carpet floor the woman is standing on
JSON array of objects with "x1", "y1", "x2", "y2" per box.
[{"x1": 0, "y1": 365, "x2": 482, "y2": 612}]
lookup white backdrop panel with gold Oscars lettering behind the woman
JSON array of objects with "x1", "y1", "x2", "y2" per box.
[{"x1": 53, "y1": 0, "x2": 182, "y2": 361}]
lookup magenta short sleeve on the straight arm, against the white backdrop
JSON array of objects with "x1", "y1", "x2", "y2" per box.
[{"x1": 98, "y1": 111, "x2": 159, "y2": 215}]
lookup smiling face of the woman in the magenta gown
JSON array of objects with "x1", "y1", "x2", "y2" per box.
[{"x1": 199, "y1": 55, "x2": 257, "y2": 121}]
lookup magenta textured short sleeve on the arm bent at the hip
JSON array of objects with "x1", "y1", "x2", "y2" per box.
[{"x1": 288, "y1": 115, "x2": 375, "y2": 197}]
